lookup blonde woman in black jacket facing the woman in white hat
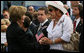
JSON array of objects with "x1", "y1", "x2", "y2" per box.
[{"x1": 6, "y1": 6, "x2": 34, "y2": 52}]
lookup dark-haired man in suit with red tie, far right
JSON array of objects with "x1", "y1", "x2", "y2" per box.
[{"x1": 73, "y1": 4, "x2": 83, "y2": 34}]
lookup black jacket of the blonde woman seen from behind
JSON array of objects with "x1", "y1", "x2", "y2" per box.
[{"x1": 6, "y1": 22, "x2": 35, "y2": 52}]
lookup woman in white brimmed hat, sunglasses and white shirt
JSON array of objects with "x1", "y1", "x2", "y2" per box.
[{"x1": 39, "y1": 1, "x2": 73, "y2": 52}]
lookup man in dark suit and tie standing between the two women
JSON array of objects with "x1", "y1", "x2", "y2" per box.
[{"x1": 37, "y1": 8, "x2": 51, "y2": 37}]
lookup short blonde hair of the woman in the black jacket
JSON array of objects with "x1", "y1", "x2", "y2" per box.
[{"x1": 9, "y1": 6, "x2": 27, "y2": 21}]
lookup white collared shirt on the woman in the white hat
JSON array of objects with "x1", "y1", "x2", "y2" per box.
[{"x1": 47, "y1": 15, "x2": 73, "y2": 50}]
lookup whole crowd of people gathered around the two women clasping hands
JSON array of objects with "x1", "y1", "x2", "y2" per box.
[{"x1": 1, "y1": 1, "x2": 83, "y2": 52}]
